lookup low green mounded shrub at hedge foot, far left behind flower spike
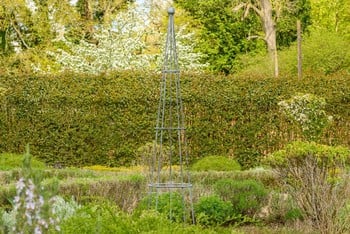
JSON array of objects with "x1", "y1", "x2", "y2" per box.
[{"x1": 0, "y1": 153, "x2": 46, "y2": 171}]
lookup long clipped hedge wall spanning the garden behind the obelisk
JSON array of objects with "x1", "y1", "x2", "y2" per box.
[{"x1": 0, "y1": 72, "x2": 350, "y2": 167}]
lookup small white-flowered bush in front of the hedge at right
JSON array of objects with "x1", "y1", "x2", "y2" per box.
[{"x1": 278, "y1": 93, "x2": 333, "y2": 140}]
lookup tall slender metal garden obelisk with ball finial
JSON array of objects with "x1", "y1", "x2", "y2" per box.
[{"x1": 148, "y1": 7, "x2": 194, "y2": 222}]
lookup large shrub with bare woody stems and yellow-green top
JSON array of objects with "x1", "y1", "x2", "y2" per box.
[{"x1": 266, "y1": 142, "x2": 350, "y2": 233}]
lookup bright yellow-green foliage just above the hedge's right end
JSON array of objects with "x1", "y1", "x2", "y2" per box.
[{"x1": 236, "y1": 29, "x2": 350, "y2": 77}]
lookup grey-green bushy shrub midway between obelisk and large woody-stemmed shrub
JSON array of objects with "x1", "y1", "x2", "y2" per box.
[{"x1": 214, "y1": 179, "x2": 268, "y2": 216}]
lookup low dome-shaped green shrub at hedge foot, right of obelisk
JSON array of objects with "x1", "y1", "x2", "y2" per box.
[{"x1": 192, "y1": 156, "x2": 241, "y2": 171}]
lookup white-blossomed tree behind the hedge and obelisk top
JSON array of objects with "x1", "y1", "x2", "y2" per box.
[{"x1": 49, "y1": 1, "x2": 207, "y2": 74}]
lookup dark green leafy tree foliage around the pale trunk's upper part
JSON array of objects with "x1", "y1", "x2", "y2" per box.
[{"x1": 175, "y1": 0, "x2": 310, "y2": 73}]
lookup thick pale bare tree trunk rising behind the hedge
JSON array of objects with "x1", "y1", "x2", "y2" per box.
[{"x1": 260, "y1": 0, "x2": 278, "y2": 77}]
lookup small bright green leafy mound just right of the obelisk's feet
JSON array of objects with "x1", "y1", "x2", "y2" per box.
[{"x1": 194, "y1": 195, "x2": 232, "y2": 226}]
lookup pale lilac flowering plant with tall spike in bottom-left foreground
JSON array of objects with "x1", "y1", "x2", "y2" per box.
[{"x1": 1, "y1": 146, "x2": 79, "y2": 234}]
